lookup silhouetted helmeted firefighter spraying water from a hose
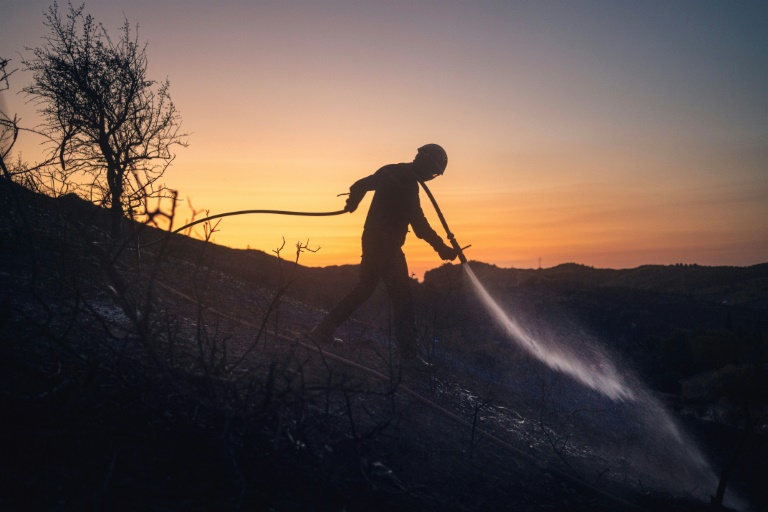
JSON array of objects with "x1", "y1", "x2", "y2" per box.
[{"x1": 309, "y1": 144, "x2": 458, "y2": 370}]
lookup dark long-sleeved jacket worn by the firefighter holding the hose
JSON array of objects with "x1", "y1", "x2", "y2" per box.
[{"x1": 347, "y1": 163, "x2": 443, "y2": 254}]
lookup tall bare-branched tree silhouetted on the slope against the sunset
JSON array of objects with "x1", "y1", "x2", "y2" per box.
[{"x1": 23, "y1": 2, "x2": 187, "y2": 239}]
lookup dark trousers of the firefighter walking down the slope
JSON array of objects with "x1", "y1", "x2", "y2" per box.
[{"x1": 322, "y1": 247, "x2": 416, "y2": 357}]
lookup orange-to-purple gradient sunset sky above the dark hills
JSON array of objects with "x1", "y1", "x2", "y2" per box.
[{"x1": 0, "y1": 0, "x2": 768, "y2": 276}]
